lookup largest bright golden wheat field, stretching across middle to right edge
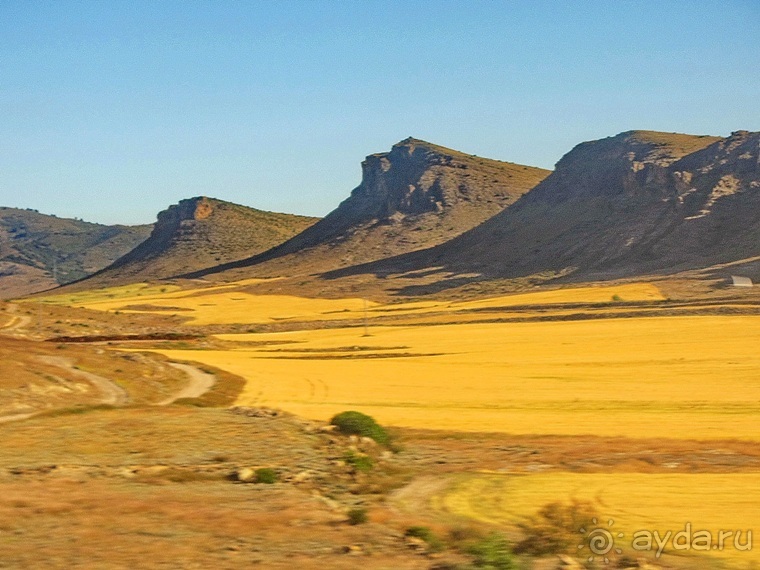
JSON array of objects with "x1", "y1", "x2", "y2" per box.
[{"x1": 145, "y1": 317, "x2": 760, "y2": 439}]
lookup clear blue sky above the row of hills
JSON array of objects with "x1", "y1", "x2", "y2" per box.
[{"x1": 0, "y1": 0, "x2": 760, "y2": 223}]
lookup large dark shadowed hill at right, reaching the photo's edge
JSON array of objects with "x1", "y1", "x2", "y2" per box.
[{"x1": 330, "y1": 131, "x2": 760, "y2": 286}]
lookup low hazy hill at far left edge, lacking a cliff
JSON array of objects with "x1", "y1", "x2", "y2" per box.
[{"x1": 0, "y1": 208, "x2": 151, "y2": 299}]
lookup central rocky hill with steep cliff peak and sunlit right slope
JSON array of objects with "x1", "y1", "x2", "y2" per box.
[{"x1": 187, "y1": 138, "x2": 549, "y2": 276}]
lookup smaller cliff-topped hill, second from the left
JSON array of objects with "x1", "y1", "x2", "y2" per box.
[{"x1": 81, "y1": 197, "x2": 319, "y2": 287}]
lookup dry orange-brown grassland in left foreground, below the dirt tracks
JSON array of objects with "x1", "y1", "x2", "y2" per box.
[{"x1": 0, "y1": 407, "x2": 436, "y2": 569}]
